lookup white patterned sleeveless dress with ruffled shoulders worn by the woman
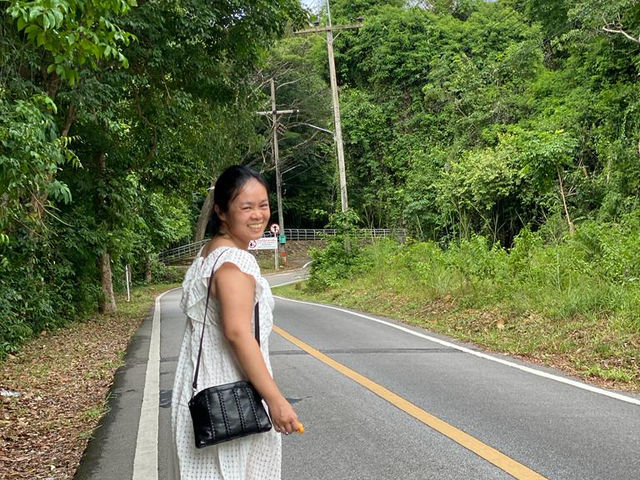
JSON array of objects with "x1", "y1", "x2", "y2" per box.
[{"x1": 171, "y1": 246, "x2": 282, "y2": 480}]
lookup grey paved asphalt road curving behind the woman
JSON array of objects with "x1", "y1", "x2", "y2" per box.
[{"x1": 76, "y1": 274, "x2": 640, "y2": 480}]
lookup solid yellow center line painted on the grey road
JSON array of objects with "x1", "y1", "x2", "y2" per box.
[{"x1": 273, "y1": 325, "x2": 546, "y2": 480}]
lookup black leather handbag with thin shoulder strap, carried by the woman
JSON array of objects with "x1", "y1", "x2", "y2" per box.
[{"x1": 189, "y1": 252, "x2": 271, "y2": 448}]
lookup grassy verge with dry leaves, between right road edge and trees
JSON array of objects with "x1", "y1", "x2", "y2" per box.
[{"x1": 276, "y1": 220, "x2": 640, "y2": 392}]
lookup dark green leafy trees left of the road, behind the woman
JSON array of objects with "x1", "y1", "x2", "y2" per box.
[{"x1": 0, "y1": 0, "x2": 303, "y2": 356}]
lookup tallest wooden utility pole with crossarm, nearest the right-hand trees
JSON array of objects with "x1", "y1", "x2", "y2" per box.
[{"x1": 294, "y1": 0, "x2": 362, "y2": 212}]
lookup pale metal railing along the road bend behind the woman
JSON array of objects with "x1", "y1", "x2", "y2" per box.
[{"x1": 158, "y1": 228, "x2": 407, "y2": 263}]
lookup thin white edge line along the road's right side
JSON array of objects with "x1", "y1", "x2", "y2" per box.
[{"x1": 276, "y1": 296, "x2": 640, "y2": 405}]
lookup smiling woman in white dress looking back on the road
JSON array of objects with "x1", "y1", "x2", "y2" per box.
[{"x1": 171, "y1": 166, "x2": 298, "y2": 480}]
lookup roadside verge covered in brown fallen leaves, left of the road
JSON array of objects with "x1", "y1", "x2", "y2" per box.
[{"x1": 0, "y1": 283, "x2": 179, "y2": 480}]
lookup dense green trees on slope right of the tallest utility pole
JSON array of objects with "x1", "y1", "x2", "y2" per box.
[{"x1": 308, "y1": 0, "x2": 640, "y2": 242}]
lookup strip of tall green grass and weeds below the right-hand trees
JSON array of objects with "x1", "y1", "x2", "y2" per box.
[{"x1": 309, "y1": 214, "x2": 640, "y2": 331}]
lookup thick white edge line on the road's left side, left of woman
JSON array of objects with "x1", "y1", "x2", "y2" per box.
[{"x1": 131, "y1": 287, "x2": 181, "y2": 480}]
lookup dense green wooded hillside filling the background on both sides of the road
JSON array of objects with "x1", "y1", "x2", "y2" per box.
[{"x1": 0, "y1": 0, "x2": 640, "y2": 378}]
